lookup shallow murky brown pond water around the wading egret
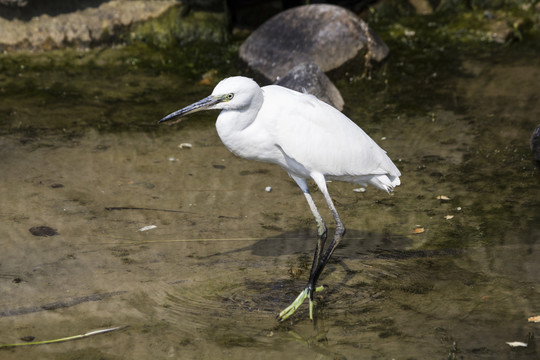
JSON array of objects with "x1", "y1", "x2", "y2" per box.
[{"x1": 0, "y1": 32, "x2": 540, "y2": 359}]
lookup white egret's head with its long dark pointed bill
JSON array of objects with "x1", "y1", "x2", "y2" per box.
[{"x1": 158, "y1": 76, "x2": 262, "y2": 123}]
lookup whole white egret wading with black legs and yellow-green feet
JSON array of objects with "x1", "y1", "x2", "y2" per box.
[{"x1": 159, "y1": 76, "x2": 401, "y2": 321}]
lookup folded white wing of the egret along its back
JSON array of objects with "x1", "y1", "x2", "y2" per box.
[{"x1": 259, "y1": 86, "x2": 400, "y2": 177}]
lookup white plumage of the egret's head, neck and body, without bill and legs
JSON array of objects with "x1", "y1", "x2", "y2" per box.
[{"x1": 212, "y1": 77, "x2": 401, "y2": 191}]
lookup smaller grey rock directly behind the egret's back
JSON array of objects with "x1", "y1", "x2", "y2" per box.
[{"x1": 275, "y1": 63, "x2": 345, "y2": 111}]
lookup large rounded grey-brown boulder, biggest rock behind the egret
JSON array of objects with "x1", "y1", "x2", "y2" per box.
[{"x1": 240, "y1": 4, "x2": 389, "y2": 82}]
